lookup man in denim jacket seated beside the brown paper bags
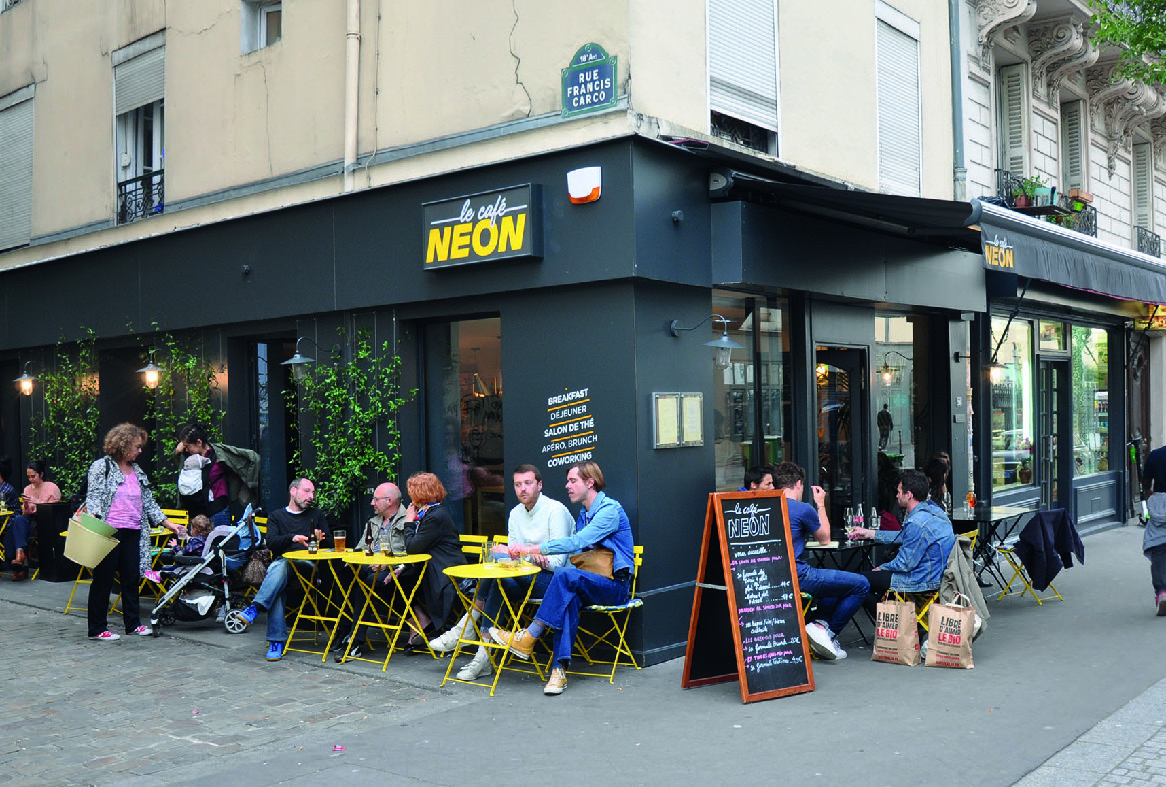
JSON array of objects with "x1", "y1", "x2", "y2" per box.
[{"x1": 850, "y1": 470, "x2": 955, "y2": 603}]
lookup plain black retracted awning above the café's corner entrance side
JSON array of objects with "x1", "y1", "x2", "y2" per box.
[{"x1": 710, "y1": 170, "x2": 979, "y2": 252}]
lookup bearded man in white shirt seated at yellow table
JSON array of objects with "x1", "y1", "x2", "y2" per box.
[{"x1": 429, "y1": 464, "x2": 575, "y2": 681}]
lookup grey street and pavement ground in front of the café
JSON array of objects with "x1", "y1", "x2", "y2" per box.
[{"x1": 0, "y1": 526, "x2": 1166, "y2": 787}]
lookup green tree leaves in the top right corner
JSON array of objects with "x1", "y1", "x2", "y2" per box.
[{"x1": 1089, "y1": 0, "x2": 1166, "y2": 83}]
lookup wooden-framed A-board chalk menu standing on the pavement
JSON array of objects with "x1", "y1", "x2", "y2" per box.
[{"x1": 681, "y1": 491, "x2": 814, "y2": 702}]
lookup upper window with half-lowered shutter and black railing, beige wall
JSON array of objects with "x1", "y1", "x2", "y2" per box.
[{"x1": 113, "y1": 38, "x2": 166, "y2": 224}]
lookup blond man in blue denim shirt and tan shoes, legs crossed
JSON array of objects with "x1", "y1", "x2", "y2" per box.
[{"x1": 490, "y1": 462, "x2": 634, "y2": 695}]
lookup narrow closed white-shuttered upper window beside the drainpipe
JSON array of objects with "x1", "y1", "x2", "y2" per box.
[{"x1": 875, "y1": 2, "x2": 922, "y2": 196}]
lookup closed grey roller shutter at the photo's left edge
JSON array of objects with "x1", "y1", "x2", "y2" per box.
[{"x1": 0, "y1": 89, "x2": 33, "y2": 250}]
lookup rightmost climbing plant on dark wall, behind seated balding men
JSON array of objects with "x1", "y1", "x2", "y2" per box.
[{"x1": 288, "y1": 328, "x2": 417, "y2": 517}]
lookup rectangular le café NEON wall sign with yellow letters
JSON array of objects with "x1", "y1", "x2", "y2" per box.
[{"x1": 421, "y1": 183, "x2": 542, "y2": 268}]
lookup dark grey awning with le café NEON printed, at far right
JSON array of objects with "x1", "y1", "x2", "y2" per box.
[{"x1": 971, "y1": 199, "x2": 1166, "y2": 303}]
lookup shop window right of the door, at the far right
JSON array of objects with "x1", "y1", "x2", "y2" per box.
[{"x1": 1070, "y1": 325, "x2": 1109, "y2": 476}]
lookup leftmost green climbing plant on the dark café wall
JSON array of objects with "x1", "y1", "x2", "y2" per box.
[{"x1": 28, "y1": 329, "x2": 101, "y2": 498}]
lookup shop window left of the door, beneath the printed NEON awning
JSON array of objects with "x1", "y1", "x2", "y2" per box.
[{"x1": 991, "y1": 317, "x2": 1035, "y2": 491}]
